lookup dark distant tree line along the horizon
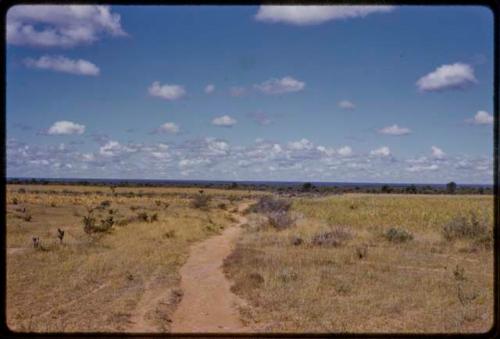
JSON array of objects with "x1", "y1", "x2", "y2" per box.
[{"x1": 7, "y1": 179, "x2": 493, "y2": 194}]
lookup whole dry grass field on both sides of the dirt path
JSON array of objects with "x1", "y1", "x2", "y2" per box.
[{"x1": 6, "y1": 185, "x2": 493, "y2": 333}]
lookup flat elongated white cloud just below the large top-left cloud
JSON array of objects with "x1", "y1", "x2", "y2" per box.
[{"x1": 24, "y1": 55, "x2": 100, "y2": 76}]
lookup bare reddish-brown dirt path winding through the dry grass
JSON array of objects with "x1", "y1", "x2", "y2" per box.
[{"x1": 171, "y1": 204, "x2": 250, "y2": 333}]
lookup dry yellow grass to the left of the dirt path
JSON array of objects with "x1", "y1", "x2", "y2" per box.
[{"x1": 7, "y1": 185, "x2": 246, "y2": 332}]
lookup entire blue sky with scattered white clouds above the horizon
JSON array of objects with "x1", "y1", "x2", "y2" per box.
[{"x1": 6, "y1": 5, "x2": 493, "y2": 184}]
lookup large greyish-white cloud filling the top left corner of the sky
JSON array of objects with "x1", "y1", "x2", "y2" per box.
[{"x1": 7, "y1": 5, "x2": 126, "y2": 47}]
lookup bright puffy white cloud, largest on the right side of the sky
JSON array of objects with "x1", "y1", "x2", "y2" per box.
[{"x1": 417, "y1": 62, "x2": 477, "y2": 91}]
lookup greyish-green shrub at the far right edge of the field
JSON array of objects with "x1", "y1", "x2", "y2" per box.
[{"x1": 442, "y1": 212, "x2": 491, "y2": 241}]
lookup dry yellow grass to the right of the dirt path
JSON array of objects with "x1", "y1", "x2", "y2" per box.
[{"x1": 225, "y1": 194, "x2": 493, "y2": 333}]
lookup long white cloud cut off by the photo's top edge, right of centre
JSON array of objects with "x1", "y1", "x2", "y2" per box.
[{"x1": 255, "y1": 5, "x2": 394, "y2": 25}]
